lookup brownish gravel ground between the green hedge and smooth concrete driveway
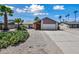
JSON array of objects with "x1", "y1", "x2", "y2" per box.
[{"x1": 0, "y1": 30, "x2": 63, "y2": 54}]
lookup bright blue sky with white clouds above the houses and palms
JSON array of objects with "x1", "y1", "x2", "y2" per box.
[{"x1": 0, "y1": 4, "x2": 79, "y2": 22}]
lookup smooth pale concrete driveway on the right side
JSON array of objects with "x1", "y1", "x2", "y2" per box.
[{"x1": 43, "y1": 29, "x2": 79, "y2": 54}]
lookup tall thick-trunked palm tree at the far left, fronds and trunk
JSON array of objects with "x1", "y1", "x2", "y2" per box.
[{"x1": 0, "y1": 5, "x2": 13, "y2": 30}]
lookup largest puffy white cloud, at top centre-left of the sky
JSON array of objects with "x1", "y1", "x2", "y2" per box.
[{"x1": 16, "y1": 4, "x2": 44, "y2": 13}]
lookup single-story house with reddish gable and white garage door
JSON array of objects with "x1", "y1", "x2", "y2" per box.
[{"x1": 33, "y1": 17, "x2": 58, "y2": 30}]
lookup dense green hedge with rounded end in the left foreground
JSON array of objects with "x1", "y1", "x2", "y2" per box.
[{"x1": 0, "y1": 30, "x2": 29, "y2": 48}]
